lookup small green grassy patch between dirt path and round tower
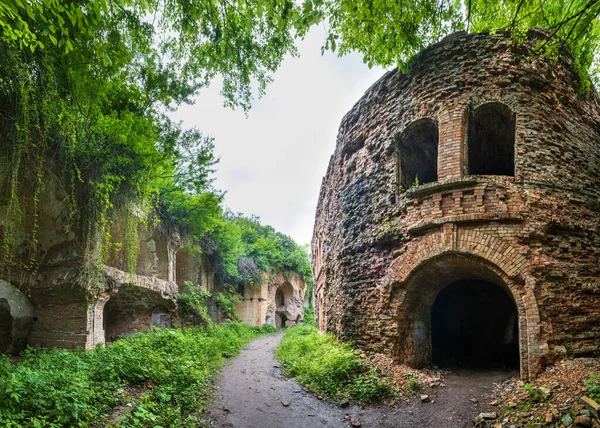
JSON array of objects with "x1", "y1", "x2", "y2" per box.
[{"x1": 276, "y1": 325, "x2": 390, "y2": 403}]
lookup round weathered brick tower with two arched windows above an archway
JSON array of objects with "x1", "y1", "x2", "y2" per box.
[{"x1": 312, "y1": 33, "x2": 600, "y2": 378}]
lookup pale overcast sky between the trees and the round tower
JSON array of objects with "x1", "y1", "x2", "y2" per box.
[{"x1": 169, "y1": 27, "x2": 384, "y2": 244}]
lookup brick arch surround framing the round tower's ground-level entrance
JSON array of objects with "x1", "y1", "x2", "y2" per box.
[{"x1": 381, "y1": 225, "x2": 541, "y2": 378}]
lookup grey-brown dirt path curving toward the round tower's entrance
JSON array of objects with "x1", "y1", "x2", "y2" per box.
[{"x1": 208, "y1": 332, "x2": 516, "y2": 428}]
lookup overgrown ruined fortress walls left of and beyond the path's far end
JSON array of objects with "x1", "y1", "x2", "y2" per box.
[{"x1": 0, "y1": 175, "x2": 306, "y2": 353}]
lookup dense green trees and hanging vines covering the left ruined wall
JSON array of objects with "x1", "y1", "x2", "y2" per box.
[{"x1": 0, "y1": 0, "x2": 318, "y2": 288}]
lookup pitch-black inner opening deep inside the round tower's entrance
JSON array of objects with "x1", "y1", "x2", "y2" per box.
[{"x1": 431, "y1": 280, "x2": 519, "y2": 368}]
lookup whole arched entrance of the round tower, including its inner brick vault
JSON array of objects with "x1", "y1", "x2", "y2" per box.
[{"x1": 396, "y1": 253, "x2": 527, "y2": 374}]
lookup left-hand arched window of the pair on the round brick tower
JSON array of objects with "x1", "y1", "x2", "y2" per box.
[{"x1": 398, "y1": 119, "x2": 439, "y2": 189}]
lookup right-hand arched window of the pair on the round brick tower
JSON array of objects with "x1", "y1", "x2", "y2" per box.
[{"x1": 467, "y1": 102, "x2": 516, "y2": 176}]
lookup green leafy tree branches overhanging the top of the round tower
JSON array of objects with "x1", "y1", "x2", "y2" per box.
[{"x1": 318, "y1": 0, "x2": 600, "y2": 87}]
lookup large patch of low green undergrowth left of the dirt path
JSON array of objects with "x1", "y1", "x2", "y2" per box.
[{"x1": 0, "y1": 323, "x2": 272, "y2": 427}]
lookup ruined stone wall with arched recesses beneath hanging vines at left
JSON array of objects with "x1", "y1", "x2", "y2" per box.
[{"x1": 0, "y1": 169, "x2": 200, "y2": 353}]
